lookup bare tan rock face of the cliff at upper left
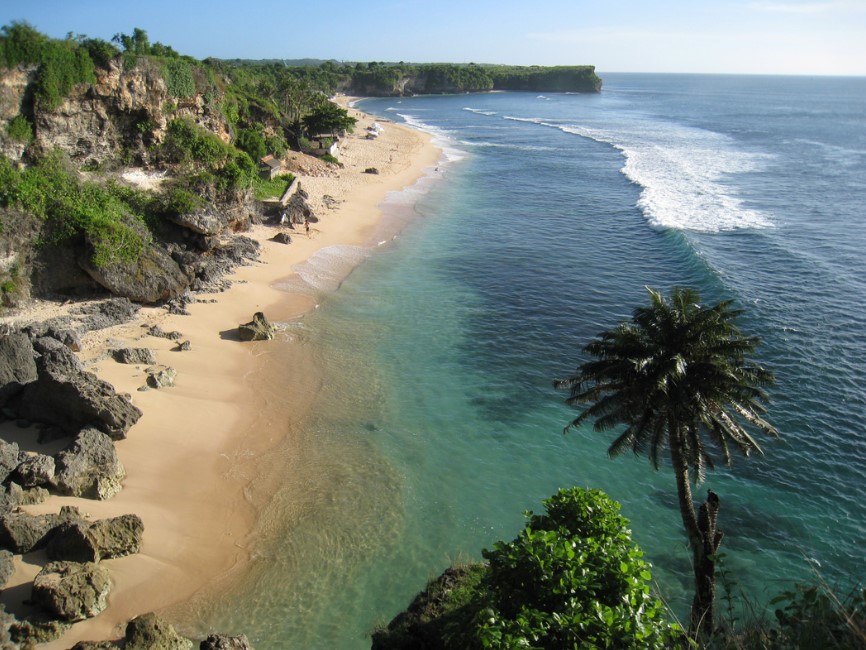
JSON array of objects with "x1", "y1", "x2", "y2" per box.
[{"x1": 0, "y1": 58, "x2": 231, "y2": 165}]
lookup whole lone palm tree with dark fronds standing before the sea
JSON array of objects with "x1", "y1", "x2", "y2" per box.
[{"x1": 555, "y1": 287, "x2": 778, "y2": 631}]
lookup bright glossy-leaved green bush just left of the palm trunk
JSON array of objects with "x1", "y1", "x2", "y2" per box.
[{"x1": 476, "y1": 488, "x2": 681, "y2": 648}]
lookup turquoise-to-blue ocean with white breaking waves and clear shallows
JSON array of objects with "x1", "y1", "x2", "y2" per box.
[{"x1": 186, "y1": 74, "x2": 866, "y2": 650}]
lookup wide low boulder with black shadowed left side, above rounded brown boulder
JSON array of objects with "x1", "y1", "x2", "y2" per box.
[{"x1": 46, "y1": 515, "x2": 144, "y2": 562}]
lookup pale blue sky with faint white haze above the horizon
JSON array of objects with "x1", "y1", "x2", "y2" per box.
[{"x1": 0, "y1": 0, "x2": 866, "y2": 76}]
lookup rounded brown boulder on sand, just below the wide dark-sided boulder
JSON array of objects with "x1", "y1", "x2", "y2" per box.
[{"x1": 31, "y1": 562, "x2": 111, "y2": 621}]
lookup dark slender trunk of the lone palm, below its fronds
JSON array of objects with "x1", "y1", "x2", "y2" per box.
[{"x1": 670, "y1": 428, "x2": 721, "y2": 634}]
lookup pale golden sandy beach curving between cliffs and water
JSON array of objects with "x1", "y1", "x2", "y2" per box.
[{"x1": 0, "y1": 98, "x2": 440, "y2": 648}]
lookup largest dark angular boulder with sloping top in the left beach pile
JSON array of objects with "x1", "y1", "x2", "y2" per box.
[{"x1": 19, "y1": 338, "x2": 141, "y2": 440}]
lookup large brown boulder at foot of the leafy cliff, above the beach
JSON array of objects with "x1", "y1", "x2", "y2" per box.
[{"x1": 78, "y1": 239, "x2": 189, "y2": 304}]
